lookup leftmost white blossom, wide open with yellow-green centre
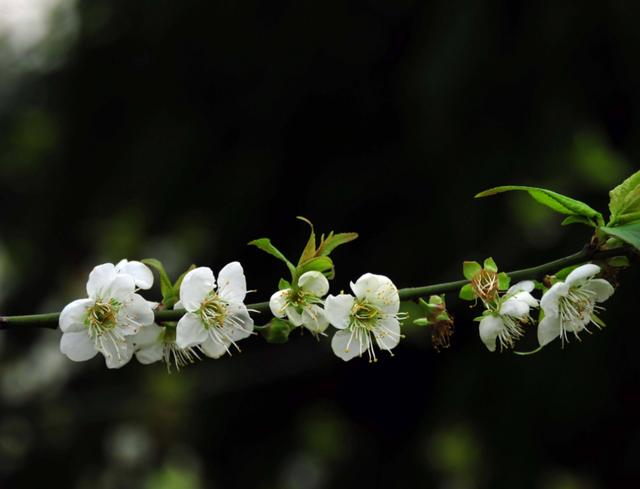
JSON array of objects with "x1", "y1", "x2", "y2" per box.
[{"x1": 59, "y1": 262, "x2": 154, "y2": 368}]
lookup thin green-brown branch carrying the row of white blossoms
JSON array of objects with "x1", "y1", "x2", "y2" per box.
[{"x1": 0, "y1": 245, "x2": 637, "y2": 329}]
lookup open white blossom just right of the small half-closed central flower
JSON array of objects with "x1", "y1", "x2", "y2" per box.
[{"x1": 325, "y1": 273, "x2": 402, "y2": 362}]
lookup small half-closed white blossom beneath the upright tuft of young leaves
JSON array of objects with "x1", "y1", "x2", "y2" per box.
[{"x1": 269, "y1": 271, "x2": 329, "y2": 334}]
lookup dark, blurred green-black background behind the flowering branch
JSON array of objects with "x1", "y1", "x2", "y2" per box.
[{"x1": 0, "y1": 0, "x2": 640, "y2": 489}]
